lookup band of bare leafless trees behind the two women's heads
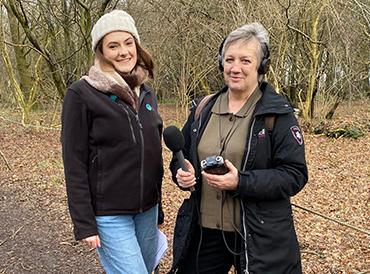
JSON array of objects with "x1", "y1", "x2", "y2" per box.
[{"x1": 2, "y1": 0, "x2": 370, "y2": 121}]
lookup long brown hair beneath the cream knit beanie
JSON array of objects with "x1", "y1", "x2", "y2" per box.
[{"x1": 95, "y1": 36, "x2": 154, "y2": 79}]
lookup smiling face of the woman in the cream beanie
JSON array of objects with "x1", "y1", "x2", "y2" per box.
[{"x1": 102, "y1": 31, "x2": 137, "y2": 73}]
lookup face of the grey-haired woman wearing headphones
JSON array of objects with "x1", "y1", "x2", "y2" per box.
[{"x1": 224, "y1": 38, "x2": 260, "y2": 93}]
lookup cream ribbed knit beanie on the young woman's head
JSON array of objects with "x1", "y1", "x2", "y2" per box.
[{"x1": 91, "y1": 10, "x2": 140, "y2": 51}]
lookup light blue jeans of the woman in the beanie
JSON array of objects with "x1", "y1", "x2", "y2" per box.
[{"x1": 96, "y1": 205, "x2": 158, "y2": 274}]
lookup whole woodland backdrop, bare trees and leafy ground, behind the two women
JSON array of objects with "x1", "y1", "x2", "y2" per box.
[{"x1": 0, "y1": 0, "x2": 370, "y2": 274}]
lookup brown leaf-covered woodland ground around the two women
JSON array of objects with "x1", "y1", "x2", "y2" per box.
[{"x1": 0, "y1": 102, "x2": 370, "y2": 274}]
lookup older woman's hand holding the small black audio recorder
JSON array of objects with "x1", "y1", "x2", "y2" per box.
[{"x1": 202, "y1": 160, "x2": 239, "y2": 190}]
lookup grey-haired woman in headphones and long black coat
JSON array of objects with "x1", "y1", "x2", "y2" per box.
[{"x1": 170, "y1": 23, "x2": 307, "y2": 274}]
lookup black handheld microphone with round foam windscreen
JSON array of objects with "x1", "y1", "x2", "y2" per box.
[{"x1": 163, "y1": 126, "x2": 195, "y2": 192}]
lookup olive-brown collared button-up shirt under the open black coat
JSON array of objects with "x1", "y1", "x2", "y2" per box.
[{"x1": 198, "y1": 88, "x2": 262, "y2": 231}]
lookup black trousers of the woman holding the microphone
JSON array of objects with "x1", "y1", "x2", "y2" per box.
[{"x1": 176, "y1": 228, "x2": 241, "y2": 274}]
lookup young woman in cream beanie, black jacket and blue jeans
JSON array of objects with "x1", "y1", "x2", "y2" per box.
[{"x1": 62, "y1": 10, "x2": 163, "y2": 274}]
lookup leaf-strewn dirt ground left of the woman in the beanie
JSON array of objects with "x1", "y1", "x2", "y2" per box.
[{"x1": 0, "y1": 122, "x2": 101, "y2": 274}]
